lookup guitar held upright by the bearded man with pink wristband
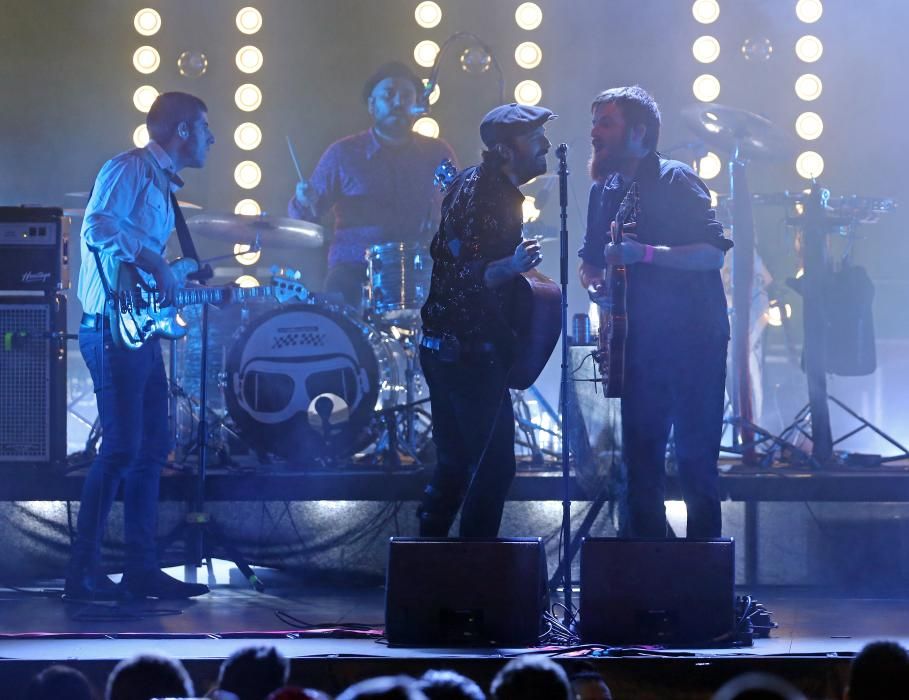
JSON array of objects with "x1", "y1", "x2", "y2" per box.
[{"x1": 594, "y1": 182, "x2": 640, "y2": 398}]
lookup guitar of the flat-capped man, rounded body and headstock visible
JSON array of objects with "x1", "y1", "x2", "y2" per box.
[{"x1": 433, "y1": 158, "x2": 562, "y2": 389}]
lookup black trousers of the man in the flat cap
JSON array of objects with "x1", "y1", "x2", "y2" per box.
[{"x1": 419, "y1": 348, "x2": 516, "y2": 537}]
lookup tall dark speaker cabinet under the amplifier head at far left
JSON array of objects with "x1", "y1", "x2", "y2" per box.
[{"x1": 0, "y1": 294, "x2": 66, "y2": 465}]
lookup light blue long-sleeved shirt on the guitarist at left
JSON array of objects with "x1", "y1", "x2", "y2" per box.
[{"x1": 77, "y1": 141, "x2": 179, "y2": 314}]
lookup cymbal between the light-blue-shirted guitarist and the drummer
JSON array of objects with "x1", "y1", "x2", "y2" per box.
[{"x1": 186, "y1": 214, "x2": 325, "y2": 248}]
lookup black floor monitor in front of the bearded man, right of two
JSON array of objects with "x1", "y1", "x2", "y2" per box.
[{"x1": 580, "y1": 538, "x2": 735, "y2": 646}]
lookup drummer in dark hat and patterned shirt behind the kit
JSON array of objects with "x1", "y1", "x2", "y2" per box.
[{"x1": 287, "y1": 62, "x2": 455, "y2": 307}]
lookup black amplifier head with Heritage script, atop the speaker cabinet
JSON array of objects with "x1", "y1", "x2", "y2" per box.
[{"x1": 0, "y1": 206, "x2": 70, "y2": 294}]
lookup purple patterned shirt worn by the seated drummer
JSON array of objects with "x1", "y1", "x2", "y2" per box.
[{"x1": 287, "y1": 129, "x2": 454, "y2": 267}]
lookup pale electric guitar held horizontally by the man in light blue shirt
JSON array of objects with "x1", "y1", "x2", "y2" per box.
[{"x1": 107, "y1": 258, "x2": 309, "y2": 350}]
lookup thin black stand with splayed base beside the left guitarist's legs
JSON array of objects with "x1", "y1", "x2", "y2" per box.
[{"x1": 161, "y1": 292, "x2": 265, "y2": 592}]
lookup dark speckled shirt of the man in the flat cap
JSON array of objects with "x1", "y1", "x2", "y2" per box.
[{"x1": 422, "y1": 159, "x2": 524, "y2": 342}]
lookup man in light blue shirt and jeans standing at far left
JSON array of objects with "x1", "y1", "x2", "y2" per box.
[{"x1": 64, "y1": 92, "x2": 215, "y2": 600}]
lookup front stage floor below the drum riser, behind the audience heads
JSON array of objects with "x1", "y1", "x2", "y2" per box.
[{"x1": 0, "y1": 571, "x2": 909, "y2": 698}]
